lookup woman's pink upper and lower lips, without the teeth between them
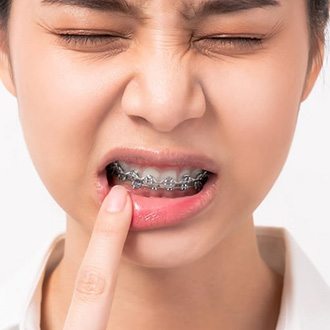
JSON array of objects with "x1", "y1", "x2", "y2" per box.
[{"x1": 97, "y1": 149, "x2": 219, "y2": 231}]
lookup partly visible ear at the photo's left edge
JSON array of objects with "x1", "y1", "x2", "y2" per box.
[{"x1": 0, "y1": 30, "x2": 16, "y2": 97}]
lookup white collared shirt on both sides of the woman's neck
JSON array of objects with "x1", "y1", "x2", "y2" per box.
[{"x1": 0, "y1": 226, "x2": 330, "y2": 330}]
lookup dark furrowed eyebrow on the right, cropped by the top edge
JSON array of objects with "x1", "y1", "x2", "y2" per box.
[{"x1": 182, "y1": 0, "x2": 280, "y2": 19}]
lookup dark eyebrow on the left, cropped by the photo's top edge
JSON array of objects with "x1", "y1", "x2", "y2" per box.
[{"x1": 41, "y1": 0, "x2": 140, "y2": 16}]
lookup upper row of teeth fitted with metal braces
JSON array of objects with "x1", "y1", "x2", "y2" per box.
[{"x1": 110, "y1": 161, "x2": 208, "y2": 190}]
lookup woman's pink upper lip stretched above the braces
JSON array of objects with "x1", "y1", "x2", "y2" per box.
[{"x1": 98, "y1": 148, "x2": 218, "y2": 174}]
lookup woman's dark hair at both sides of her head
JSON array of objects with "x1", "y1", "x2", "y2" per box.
[{"x1": 0, "y1": 0, "x2": 329, "y2": 59}]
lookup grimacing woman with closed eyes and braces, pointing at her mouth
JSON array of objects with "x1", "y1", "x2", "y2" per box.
[{"x1": 0, "y1": 0, "x2": 330, "y2": 330}]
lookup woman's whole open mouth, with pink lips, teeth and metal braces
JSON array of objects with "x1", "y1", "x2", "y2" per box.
[{"x1": 97, "y1": 148, "x2": 218, "y2": 231}]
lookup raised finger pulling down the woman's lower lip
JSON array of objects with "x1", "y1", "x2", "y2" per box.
[{"x1": 64, "y1": 186, "x2": 132, "y2": 330}]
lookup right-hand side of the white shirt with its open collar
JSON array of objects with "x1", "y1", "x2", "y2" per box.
[{"x1": 256, "y1": 226, "x2": 330, "y2": 330}]
